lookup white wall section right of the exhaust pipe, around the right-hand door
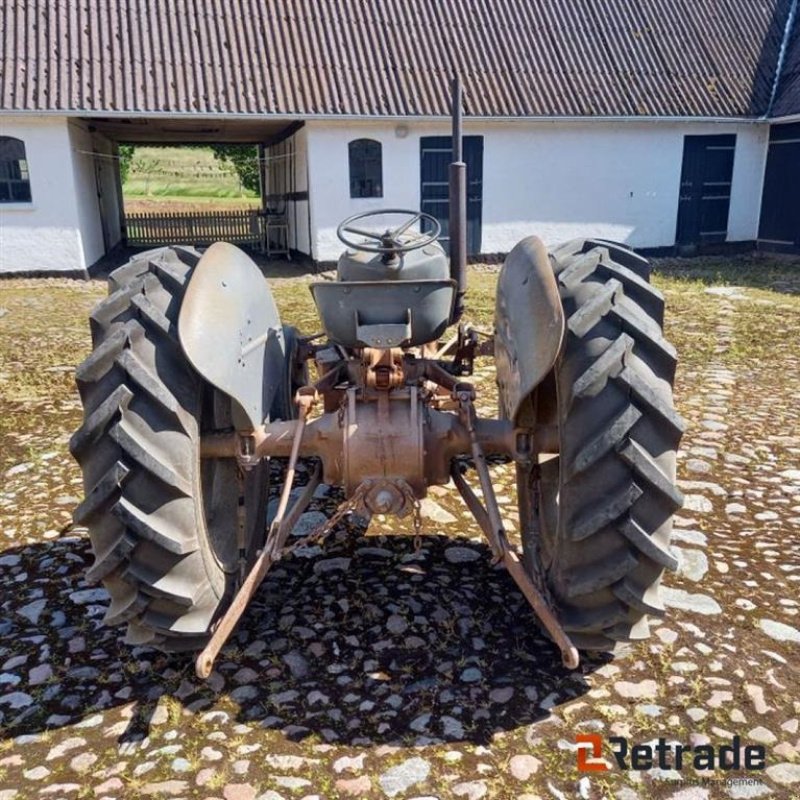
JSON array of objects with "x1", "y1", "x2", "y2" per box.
[{"x1": 482, "y1": 122, "x2": 767, "y2": 253}]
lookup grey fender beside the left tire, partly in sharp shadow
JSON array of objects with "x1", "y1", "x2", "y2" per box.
[{"x1": 178, "y1": 242, "x2": 285, "y2": 429}]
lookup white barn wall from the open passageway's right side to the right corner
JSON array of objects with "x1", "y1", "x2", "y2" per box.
[{"x1": 305, "y1": 121, "x2": 768, "y2": 261}]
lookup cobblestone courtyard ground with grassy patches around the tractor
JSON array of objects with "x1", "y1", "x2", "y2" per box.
[{"x1": 0, "y1": 260, "x2": 800, "y2": 800}]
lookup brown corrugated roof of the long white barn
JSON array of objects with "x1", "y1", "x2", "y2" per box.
[{"x1": 0, "y1": 0, "x2": 790, "y2": 117}]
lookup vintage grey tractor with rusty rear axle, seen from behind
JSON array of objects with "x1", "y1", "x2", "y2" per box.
[{"x1": 71, "y1": 88, "x2": 684, "y2": 677}]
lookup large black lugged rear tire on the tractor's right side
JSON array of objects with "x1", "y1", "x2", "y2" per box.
[{"x1": 525, "y1": 240, "x2": 685, "y2": 652}]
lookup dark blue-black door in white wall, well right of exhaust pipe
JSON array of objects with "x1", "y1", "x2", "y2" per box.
[{"x1": 675, "y1": 134, "x2": 736, "y2": 252}]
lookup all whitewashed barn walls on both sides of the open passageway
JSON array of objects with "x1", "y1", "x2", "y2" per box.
[{"x1": 0, "y1": 115, "x2": 768, "y2": 272}]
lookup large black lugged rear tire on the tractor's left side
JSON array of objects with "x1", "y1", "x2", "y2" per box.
[{"x1": 70, "y1": 247, "x2": 269, "y2": 651}]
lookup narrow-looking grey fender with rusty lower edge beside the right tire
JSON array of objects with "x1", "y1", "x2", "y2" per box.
[{"x1": 494, "y1": 236, "x2": 564, "y2": 427}]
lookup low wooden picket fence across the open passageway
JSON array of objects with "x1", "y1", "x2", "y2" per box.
[{"x1": 125, "y1": 209, "x2": 264, "y2": 246}]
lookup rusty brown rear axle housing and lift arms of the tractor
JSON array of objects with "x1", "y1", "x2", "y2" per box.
[{"x1": 196, "y1": 346, "x2": 578, "y2": 678}]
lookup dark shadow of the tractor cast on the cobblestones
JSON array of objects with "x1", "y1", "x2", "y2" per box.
[{"x1": 0, "y1": 522, "x2": 604, "y2": 747}]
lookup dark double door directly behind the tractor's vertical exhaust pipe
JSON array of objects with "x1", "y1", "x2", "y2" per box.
[{"x1": 420, "y1": 136, "x2": 483, "y2": 255}]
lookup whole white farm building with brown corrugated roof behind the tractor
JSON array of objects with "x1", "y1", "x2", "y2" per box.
[{"x1": 0, "y1": 0, "x2": 800, "y2": 273}]
